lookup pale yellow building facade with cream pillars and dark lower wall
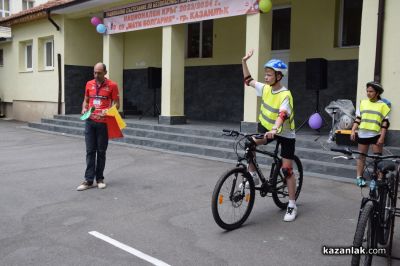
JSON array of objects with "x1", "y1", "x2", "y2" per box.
[{"x1": 0, "y1": 0, "x2": 400, "y2": 144}]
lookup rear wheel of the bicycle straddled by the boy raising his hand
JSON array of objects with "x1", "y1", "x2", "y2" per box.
[{"x1": 271, "y1": 155, "x2": 303, "y2": 210}]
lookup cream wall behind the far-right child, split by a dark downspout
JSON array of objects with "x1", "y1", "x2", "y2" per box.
[{"x1": 357, "y1": 0, "x2": 400, "y2": 130}]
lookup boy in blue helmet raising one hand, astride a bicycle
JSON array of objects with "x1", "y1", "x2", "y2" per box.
[{"x1": 242, "y1": 50, "x2": 297, "y2": 222}]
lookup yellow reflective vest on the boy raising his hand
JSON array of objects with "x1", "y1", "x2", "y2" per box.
[{"x1": 258, "y1": 85, "x2": 295, "y2": 133}]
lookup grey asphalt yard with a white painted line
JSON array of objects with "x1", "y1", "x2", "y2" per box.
[{"x1": 0, "y1": 120, "x2": 400, "y2": 266}]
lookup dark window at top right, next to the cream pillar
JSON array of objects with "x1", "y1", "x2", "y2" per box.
[{"x1": 337, "y1": 0, "x2": 363, "y2": 47}]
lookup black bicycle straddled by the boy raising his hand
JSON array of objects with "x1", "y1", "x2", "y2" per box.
[{"x1": 211, "y1": 129, "x2": 303, "y2": 230}]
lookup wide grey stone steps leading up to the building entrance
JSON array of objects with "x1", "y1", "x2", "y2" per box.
[{"x1": 28, "y1": 115, "x2": 355, "y2": 181}]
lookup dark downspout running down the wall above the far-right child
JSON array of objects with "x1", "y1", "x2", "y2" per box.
[{"x1": 374, "y1": 0, "x2": 385, "y2": 83}]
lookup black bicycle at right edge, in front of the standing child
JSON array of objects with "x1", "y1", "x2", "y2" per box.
[{"x1": 331, "y1": 148, "x2": 400, "y2": 266}]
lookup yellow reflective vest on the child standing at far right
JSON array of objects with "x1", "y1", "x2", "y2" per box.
[{"x1": 359, "y1": 99, "x2": 390, "y2": 133}]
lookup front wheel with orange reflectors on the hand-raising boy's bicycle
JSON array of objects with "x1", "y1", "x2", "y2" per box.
[{"x1": 211, "y1": 167, "x2": 255, "y2": 230}]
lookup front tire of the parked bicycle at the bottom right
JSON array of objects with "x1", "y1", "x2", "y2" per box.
[{"x1": 351, "y1": 201, "x2": 375, "y2": 266}]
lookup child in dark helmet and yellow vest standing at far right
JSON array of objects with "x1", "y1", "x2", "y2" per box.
[{"x1": 350, "y1": 81, "x2": 390, "y2": 187}]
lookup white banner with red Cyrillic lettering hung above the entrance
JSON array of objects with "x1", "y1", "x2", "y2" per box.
[{"x1": 104, "y1": 0, "x2": 259, "y2": 34}]
